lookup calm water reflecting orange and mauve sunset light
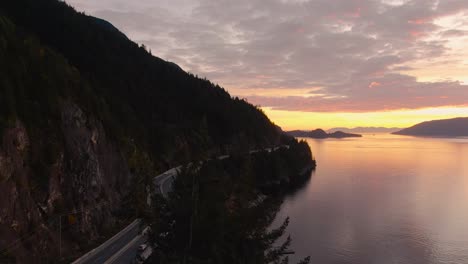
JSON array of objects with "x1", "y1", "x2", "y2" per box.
[{"x1": 276, "y1": 135, "x2": 468, "y2": 264}]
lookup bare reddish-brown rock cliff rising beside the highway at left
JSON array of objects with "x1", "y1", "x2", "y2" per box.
[{"x1": 0, "y1": 102, "x2": 131, "y2": 263}]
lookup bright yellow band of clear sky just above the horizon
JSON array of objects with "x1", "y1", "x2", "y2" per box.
[{"x1": 262, "y1": 107, "x2": 468, "y2": 130}]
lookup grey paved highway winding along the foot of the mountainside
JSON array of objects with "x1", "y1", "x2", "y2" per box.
[{"x1": 72, "y1": 145, "x2": 289, "y2": 264}]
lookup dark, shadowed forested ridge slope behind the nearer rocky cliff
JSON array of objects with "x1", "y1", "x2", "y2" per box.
[{"x1": 0, "y1": 0, "x2": 286, "y2": 165}]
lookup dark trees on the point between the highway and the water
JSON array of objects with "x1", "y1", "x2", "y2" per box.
[{"x1": 149, "y1": 141, "x2": 315, "y2": 264}]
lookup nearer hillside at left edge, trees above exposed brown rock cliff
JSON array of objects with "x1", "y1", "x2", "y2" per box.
[{"x1": 0, "y1": 12, "x2": 137, "y2": 263}]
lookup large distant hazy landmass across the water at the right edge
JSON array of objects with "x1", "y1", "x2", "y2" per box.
[{"x1": 393, "y1": 117, "x2": 468, "y2": 137}]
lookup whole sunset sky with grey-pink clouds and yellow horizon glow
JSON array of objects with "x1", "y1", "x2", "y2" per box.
[{"x1": 67, "y1": 0, "x2": 468, "y2": 129}]
